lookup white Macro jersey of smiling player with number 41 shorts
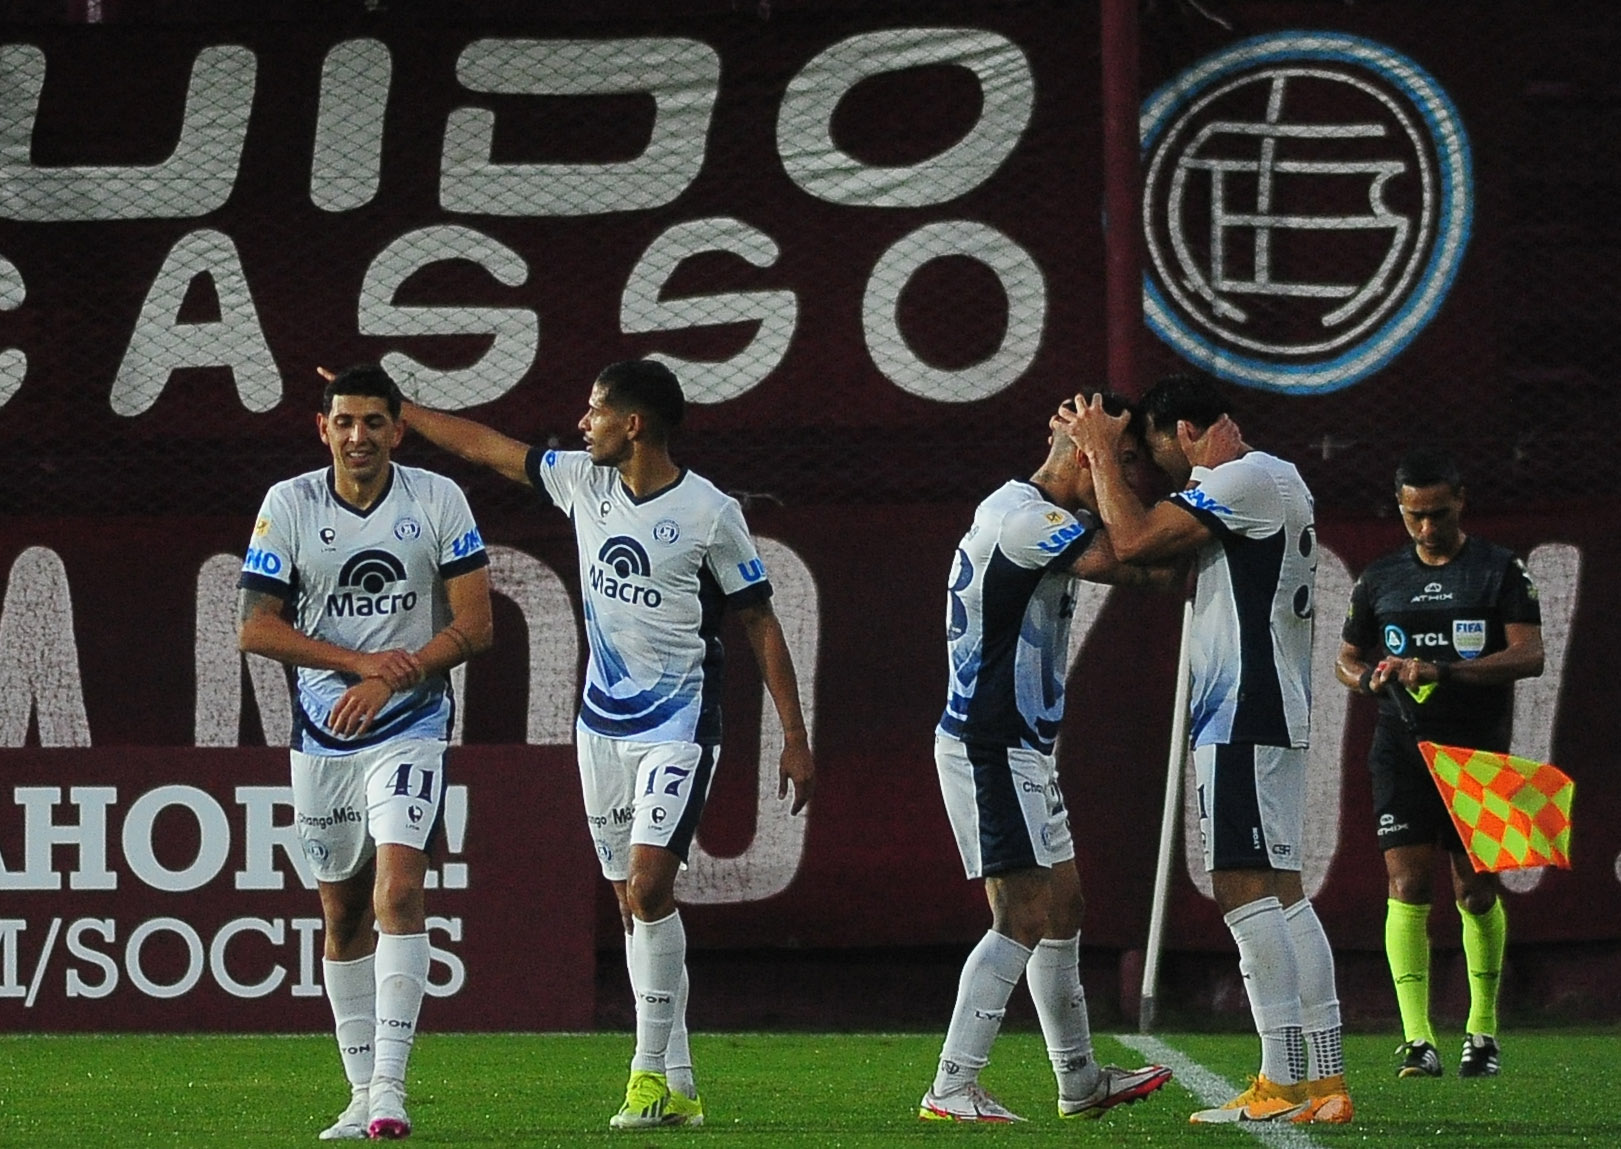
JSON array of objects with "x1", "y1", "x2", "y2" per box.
[{"x1": 238, "y1": 463, "x2": 490, "y2": 755}]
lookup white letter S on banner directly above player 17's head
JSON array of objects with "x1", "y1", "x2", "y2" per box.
[{"x1": 619, "y1": 217, "x2": 799, "y2": 404}]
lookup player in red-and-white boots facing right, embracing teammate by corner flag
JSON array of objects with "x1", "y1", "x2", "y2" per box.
[{"x1": 917, "y1": 397, "x2": 1177, "y2": 1121}]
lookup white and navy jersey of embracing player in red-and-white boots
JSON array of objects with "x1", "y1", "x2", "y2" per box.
[{"x1": 939, "y1": 480, "x2": 1097, "y2": 754}]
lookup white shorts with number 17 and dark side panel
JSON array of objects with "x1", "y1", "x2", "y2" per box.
[{"x1": 575, "y1": 729, "x2": 720, "y2": 882}]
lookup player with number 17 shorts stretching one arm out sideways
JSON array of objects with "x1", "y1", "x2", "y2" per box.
[{"x1": 405, "y1": 360, "x2": 815, "y2": 1130}]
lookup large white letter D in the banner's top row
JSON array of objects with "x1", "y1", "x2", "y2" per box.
[{"x1": 439, "y1": 37, "x2": 720, "y2": 216}]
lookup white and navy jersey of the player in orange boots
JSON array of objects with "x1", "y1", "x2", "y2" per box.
[{"x1": 1170, "y1": 451, "x2": 1316, "y2": 745}]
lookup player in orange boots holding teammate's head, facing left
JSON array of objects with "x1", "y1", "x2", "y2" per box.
[{"x1": 1060, "y1": 376, "x2": 1352, "y2": 1125}]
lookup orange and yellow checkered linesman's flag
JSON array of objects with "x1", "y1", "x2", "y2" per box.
[{"x1": 1418, "y1": 742, "x2": 1576, "y2": 873}]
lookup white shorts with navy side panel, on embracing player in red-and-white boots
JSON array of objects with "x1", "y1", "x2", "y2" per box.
[{"x1": 934, "y1": 734, "x2": 1075, "y2": 878}]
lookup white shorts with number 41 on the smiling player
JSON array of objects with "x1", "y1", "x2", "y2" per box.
[{"x1": 290, "y1": 739, "x2": 446, "y2": 882}]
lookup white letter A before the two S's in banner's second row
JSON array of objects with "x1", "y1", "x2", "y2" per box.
[{"x1": 112, "y1": 229, "x2": 282, "y2": 415}]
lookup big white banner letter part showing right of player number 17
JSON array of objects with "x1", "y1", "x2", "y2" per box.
[{"x1": 676, "y1": 538, "x2": 822, "y2": 904}]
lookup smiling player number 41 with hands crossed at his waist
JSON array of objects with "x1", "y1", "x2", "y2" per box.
[{"x1": 238, "y1": 365, "x2": 493, "y2": 1141}]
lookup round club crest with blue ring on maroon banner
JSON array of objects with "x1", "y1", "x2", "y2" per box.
[{"x1": 1140, "y1": 31, "x2": 1473, "y2": 392}]
